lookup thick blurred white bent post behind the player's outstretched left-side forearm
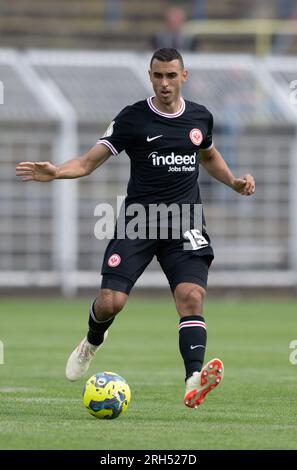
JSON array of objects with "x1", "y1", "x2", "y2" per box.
[{"x1": 19, "y1": 53, "x2": 78, "y2": 297}]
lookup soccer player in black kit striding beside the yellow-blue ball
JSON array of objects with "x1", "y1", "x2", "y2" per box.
[{"x1": 16, "y1": 48, "x2": 255, "y2": 408}]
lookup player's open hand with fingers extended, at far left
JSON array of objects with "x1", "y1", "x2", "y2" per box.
[{"x1": 16, "y1": 162, "x2": 57, "y2": 182}]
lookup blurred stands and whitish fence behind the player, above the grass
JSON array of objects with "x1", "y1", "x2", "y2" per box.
[{"x1": 0, "y1": 0, "x2": 297, "y2": 295}]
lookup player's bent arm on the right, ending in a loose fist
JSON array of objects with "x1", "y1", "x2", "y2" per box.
[{"x1": 200, "y1": 145, "x2": 255, "y2": 196}]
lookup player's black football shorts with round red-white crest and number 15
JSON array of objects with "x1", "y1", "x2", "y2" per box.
[{"x1": 101, "y1": 232, "x2": 214, "y2": 294}]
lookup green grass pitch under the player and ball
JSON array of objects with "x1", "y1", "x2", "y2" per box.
[{"x1": 0, "y1": 295, "x2": 297, "y2": 450}]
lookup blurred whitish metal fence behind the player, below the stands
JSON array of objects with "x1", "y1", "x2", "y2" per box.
[{"x1": 0, "y1": 50, "x2": 297, "y2": 294}]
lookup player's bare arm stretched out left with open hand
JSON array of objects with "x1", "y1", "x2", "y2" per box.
[{"x1": 16, "y1": 144, "x2": 111, "y2": 182}]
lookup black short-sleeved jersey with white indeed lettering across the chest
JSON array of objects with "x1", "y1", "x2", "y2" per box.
[{"x1": 97, "y1": 97, "x2": 213, "y2": 205}]
